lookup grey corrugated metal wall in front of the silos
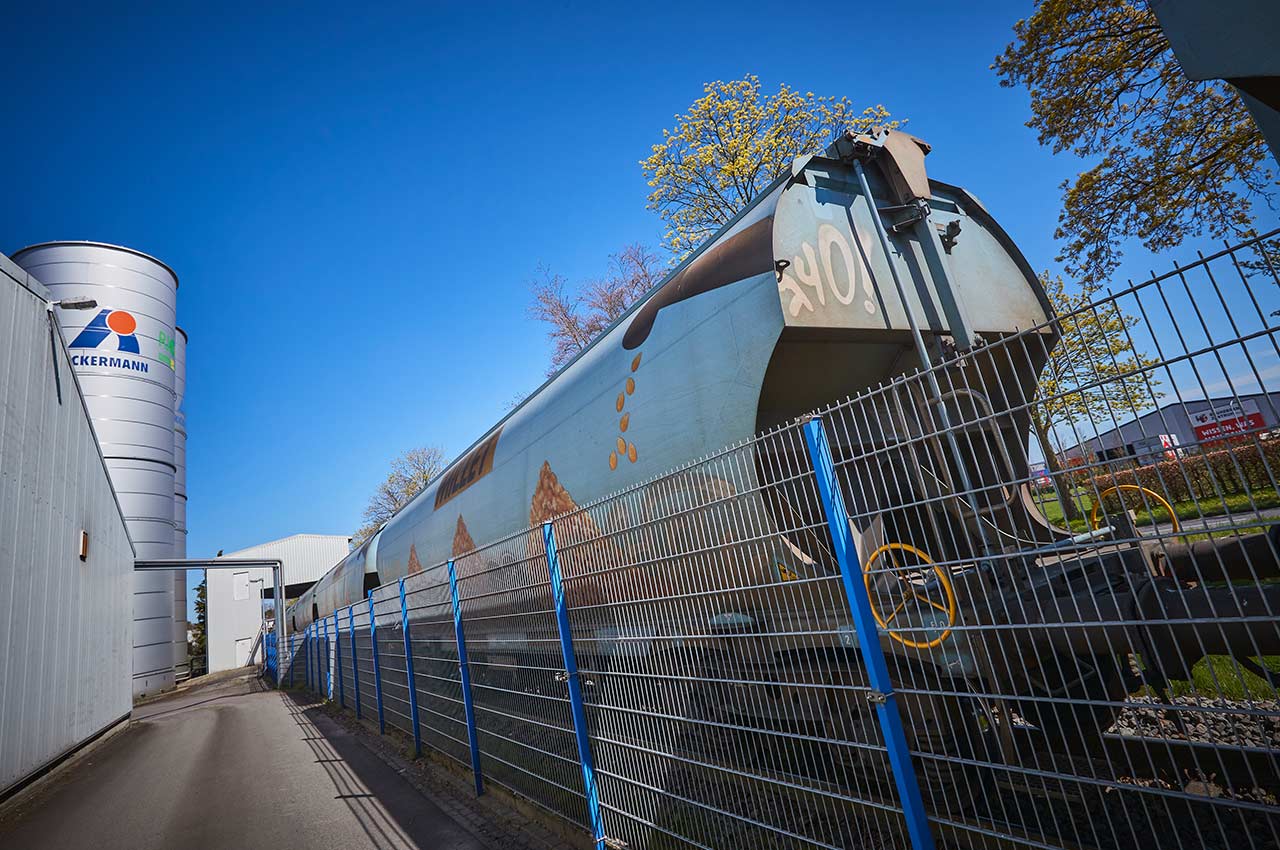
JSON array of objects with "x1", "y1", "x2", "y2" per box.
[{"x1": 0, "y1": 255, "x2": 133, "y2": 792}]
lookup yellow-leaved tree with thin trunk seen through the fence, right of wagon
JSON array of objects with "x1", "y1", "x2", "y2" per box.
[{"x1": 1030, "y1": 271, "x2": 1161, "y2": 520}]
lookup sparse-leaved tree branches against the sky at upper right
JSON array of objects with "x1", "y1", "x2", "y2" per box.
[{"x1": 992, "y1": 0, "x2": 1275, "y2": 283}]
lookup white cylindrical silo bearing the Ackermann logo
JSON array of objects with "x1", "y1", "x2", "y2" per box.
[{"x1": 13, "y1": 242, "x2": 178, "y2": 696}]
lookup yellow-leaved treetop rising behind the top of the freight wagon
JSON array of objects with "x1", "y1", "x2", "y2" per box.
[{"x1": 640, "y1": 76, "x2": 899, "y2": 257}]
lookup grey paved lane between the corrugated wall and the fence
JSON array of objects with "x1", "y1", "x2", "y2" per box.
[{"x1": 0, "y1": 676, "x2": 485, "y2": 850}]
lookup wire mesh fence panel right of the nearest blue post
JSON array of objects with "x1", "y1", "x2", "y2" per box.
[{"x1": 808, "y1": 232, "x2": 1280, "y2": 847}]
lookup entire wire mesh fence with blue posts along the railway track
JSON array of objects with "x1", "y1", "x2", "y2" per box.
[{"x1": 275, "y1": 234, "x2": 1280, "y2": 850}]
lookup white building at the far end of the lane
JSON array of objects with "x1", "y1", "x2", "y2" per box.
[{"x1": 205, "y1": 534, "x2": 351, "y2": 673}]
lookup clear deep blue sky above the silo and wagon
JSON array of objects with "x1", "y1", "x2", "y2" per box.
[{"x1": 0, "y1": 3, "x2": 1274, "y2": 611}]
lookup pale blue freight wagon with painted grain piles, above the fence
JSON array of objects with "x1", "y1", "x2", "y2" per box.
[{"x1": 289, "y1": 132, "x2": 1050, "y2": 630}]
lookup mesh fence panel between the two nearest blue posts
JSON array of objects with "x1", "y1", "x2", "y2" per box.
[{"x1": 556, "y1": 428, "x2": 921, "y2": 847}]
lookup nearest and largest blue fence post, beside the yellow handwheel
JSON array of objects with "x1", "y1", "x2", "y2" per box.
[{"x1": 804, "y1": 417, "x2": 933, "y2": 850}]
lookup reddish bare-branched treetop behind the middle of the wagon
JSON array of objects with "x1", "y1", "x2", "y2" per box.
[{"x1": 527, "y1": 243, "x2": 666, "y2": 371}]
